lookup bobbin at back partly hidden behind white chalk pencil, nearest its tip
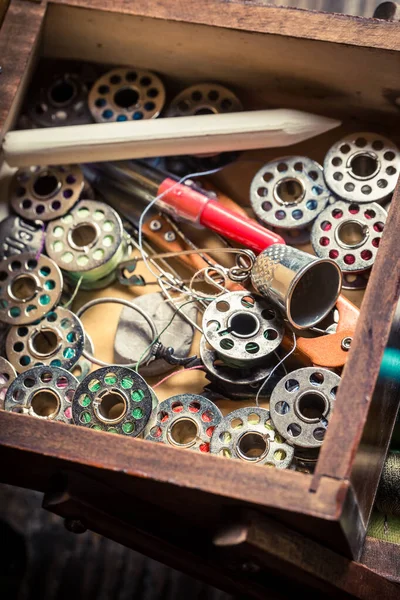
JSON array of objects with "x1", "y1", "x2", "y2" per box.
[{"x1": 166, "y1": 83, "x2": 243, "y2": 117}]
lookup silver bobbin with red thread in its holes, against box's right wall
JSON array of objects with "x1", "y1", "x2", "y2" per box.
[{"x1": 311, "y1": 201, "x2": 387, "y2": 272}]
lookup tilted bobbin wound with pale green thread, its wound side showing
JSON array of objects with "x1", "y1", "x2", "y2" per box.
[{"x1": 46, "y1": 200, "x2": 127, "y2": 289}]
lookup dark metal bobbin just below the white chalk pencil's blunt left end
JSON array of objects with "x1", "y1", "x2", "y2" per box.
[{"x1": 10, "y1": 165, "x2": 84, "y2": 221}]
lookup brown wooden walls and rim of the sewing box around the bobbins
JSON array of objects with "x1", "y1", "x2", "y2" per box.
[{"x1": 0, "y1": 0, "x2": 400, "y2": 592}]
